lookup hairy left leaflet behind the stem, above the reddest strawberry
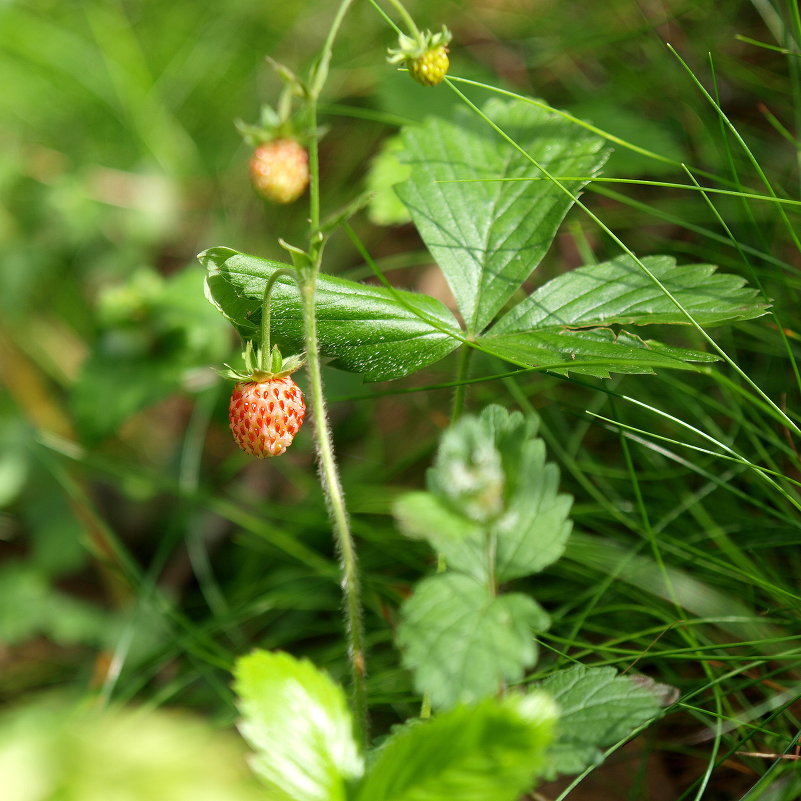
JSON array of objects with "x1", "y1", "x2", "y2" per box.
[{"x1": 199, "y1": 248, "x2": 462, "y2": 381}]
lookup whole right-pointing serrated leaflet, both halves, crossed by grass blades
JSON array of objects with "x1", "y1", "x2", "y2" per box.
[{"x1": 480, "y1": 256, "x2": 768, "y2": 377}]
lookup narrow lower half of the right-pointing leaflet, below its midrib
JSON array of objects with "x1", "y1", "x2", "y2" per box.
[{"x1": 479, "y1": 328, "x2": 717, "y2": 378}]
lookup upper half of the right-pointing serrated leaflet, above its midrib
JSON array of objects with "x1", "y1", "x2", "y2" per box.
[{"x1": 488, "y1": 256, "x2": 769, "y2": 337}]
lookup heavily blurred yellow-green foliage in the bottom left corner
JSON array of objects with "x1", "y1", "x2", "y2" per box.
[{"x1": 0, "y1": 702, "x2": 264, "y2": 801}]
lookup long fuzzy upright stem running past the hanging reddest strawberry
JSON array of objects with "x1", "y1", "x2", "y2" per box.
[{"x1": 300, "y1": 0, "x2": 368, "y2": 745}]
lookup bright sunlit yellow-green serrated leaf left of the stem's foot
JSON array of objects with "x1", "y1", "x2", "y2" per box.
[{"x1": 235, "y1": 651, "x2": 363, "y2": 801}]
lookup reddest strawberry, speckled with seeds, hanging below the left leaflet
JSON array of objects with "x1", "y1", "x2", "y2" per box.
[{"x1": 233, "y1": 375, "x2": 306, "y2": 459}]
